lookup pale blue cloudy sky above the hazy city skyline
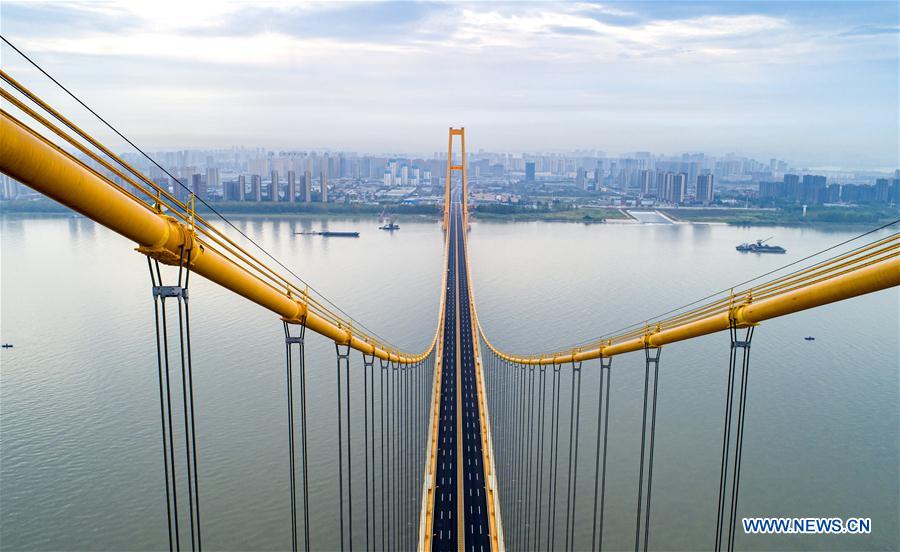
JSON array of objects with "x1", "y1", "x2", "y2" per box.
[{"x1": 0, "y1": 0, "x2": 900, "y2": 169}]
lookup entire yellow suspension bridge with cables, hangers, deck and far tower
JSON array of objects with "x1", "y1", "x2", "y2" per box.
[{"x1": 0, "y1": 39, "x2": 900, "y2": 552}]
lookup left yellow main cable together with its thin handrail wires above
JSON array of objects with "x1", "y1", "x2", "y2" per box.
[{"x1": 0, "y1": 70, "x2": 438, "y2": 363}]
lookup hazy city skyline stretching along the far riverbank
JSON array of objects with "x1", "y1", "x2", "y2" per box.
[{"x1": 0, "y1": 147, "x2": 900, "y2": 209}]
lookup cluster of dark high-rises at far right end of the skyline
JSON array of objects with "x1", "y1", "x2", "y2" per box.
[{"x1": 759, "y1": 170, "x2": 900, "y2": 205}]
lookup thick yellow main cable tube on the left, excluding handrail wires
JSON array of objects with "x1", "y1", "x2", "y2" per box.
[{"x1": 0, "y1": 113, "x2": 430, "y2": 363}]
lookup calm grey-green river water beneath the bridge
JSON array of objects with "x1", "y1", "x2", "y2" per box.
[{"x1": 0, "y1": 216, "x2": 900, "y2": 550}]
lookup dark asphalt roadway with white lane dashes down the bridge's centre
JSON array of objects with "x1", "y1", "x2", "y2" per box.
[{"x1": 431, "y1": 193, "x2": 491, "y2": 552}]
